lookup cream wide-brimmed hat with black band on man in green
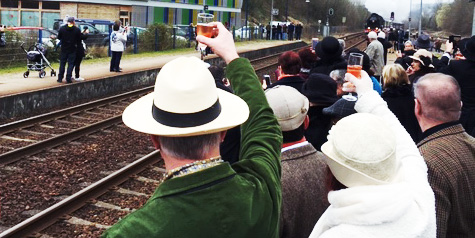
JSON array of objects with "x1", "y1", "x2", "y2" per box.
[{"x1": 122, "y1": 57, "x2": 249, "y2": 137}]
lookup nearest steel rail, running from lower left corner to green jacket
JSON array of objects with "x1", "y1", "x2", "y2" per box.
[{"x1": 0, "y1": 150, "x2": 165, "y2": 238}]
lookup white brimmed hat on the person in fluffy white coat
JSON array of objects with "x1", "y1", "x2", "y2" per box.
[{"x1": 322, "y1": 113, "x2": 399, "y2": 187}]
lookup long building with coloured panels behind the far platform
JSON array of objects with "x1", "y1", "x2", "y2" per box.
[{"x1": 0, "y1": 0, "x2": 243, "y2": 28}]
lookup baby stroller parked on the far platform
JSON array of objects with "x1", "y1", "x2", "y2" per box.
[{"x1": 20, "y1": 43, "x2": 56, "y2": 78}]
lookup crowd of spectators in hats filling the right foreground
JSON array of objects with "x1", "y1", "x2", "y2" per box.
[{"x1": 103, "y1": 20, "x2": 475, "y2": 237}]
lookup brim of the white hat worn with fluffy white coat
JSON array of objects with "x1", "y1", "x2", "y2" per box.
[{"x1": 322, "y1": 141, "x2": 389, "y2": 188}]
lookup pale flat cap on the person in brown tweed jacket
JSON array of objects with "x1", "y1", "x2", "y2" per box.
[{"x1": 266, "y1": 85, "x2": 309, "y2": 131}]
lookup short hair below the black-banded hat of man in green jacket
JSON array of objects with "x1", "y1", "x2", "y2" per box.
[{"x1": 158, "y1": 132, "x2": 221, "y2": 160}]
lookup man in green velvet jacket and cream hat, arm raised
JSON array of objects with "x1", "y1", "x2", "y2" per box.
[{"x1": 103, "y1": 23, "x2": 282, "y2": 238}]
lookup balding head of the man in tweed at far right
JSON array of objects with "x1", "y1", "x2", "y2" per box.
[{"x1": 414, "y1": 73, "x2": 461, "y2": 123}]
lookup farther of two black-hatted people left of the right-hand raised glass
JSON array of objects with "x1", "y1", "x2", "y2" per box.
[{"x1": 310, "y1": 36, "x2": 347, "y2": 75}]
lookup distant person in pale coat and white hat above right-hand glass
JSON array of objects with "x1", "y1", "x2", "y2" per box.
[{"x1": 365, "y1": 31, "x2": 384, "y2": 83}]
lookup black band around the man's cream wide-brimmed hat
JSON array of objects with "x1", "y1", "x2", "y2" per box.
[{"x1": 152, "y1": 99, "x2": 221, "y2": 128}]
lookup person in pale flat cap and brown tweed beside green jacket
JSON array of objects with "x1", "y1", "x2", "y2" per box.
[{"x1": 265, "y1": 86, "x2": 328, "y2": 238}]
